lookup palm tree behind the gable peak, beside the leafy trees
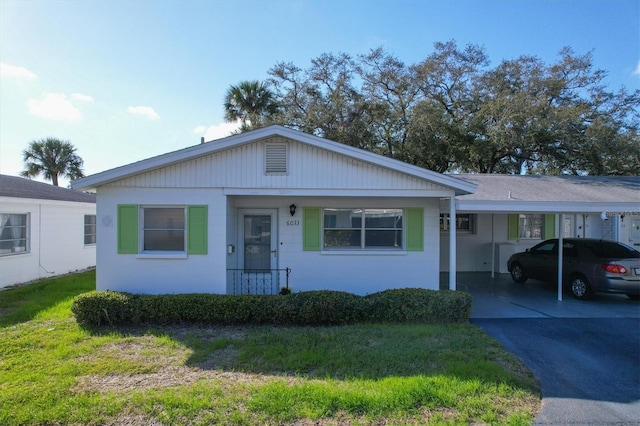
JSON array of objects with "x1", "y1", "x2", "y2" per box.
[{"x1": 224, "y1": 80, "x2": 278, "y2": 132}]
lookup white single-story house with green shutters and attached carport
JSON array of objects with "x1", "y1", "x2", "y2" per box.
[{"x1": 73, "y1": 126, "x2": 640, "y2": 294}]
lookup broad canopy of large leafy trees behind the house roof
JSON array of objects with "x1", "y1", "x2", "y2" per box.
[{"x1": 225, "y1": 41, "x2": 640, "y2": 175}]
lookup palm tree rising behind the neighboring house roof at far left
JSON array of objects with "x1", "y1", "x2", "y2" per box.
[{"x1": 20, "y1": 138, "x2": 84, "y2": 186}]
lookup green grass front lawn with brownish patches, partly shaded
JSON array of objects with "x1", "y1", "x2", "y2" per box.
[{"x1": 0, "y1": 272, "x2": 540, "y2": 425}]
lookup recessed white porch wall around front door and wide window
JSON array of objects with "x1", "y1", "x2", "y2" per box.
[{"x1": 227, "y1": 197, "x2": 440, "y2": 294}]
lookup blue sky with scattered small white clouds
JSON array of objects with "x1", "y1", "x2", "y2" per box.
[{"x1": 0, "y1": 0, "x2": 640, "y2": 185}]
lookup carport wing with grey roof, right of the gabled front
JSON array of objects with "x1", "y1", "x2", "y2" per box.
[{"x1": 440, "y1": 174, "x2": 640, "y2": 273}]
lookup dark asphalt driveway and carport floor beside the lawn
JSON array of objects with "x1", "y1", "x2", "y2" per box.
[{"x1": 445, "y1": 273, "x2": 640, "y2": 425}]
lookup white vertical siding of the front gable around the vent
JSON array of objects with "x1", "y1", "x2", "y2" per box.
[{"x1": 106, "y1": 137, "x2": 443, "y2": 191}]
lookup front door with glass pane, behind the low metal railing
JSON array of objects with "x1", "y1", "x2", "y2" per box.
[{"x1": 236, "y1": 209, "x2": 280, "y2": 294}]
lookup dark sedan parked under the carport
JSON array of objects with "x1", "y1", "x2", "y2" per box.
[{"x1": 507, "y1": 238, "x2": 640, "y2": 300}]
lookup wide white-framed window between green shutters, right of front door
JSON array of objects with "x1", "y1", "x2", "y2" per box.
[{"x1": 322, "y1": 208, "x2": 404, "y2": 250}]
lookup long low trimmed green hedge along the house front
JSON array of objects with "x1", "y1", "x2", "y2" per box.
[{"x1": 71, "y1": 288, "x2": 471, "y2": 327}]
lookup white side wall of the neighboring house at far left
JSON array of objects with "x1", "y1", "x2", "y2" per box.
[{"x1": 0, "y1": 197, "x2": 96, "y2": 288}]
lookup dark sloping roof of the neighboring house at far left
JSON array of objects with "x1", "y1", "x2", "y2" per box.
[{"x1": 0, "y1": 175, "x2": 96, "y2": 203}]
